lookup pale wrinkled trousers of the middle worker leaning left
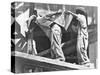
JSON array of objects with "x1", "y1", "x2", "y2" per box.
[{"x1": 51, "y1": 24, "x2": 65, "y2": 61}]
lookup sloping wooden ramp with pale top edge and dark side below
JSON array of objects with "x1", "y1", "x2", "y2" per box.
[{"x1": 12, "y1": 51, "x2": 94, "y2": 73}]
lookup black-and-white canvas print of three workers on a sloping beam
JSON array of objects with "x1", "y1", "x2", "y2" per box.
[{"x1": 11, "y1": 2, "x2": 98, "y2": 73}]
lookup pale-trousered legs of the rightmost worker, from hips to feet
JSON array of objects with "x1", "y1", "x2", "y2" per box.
[{"x1": 77, "y1": 37, "x2": 90, "y2": 64}]
